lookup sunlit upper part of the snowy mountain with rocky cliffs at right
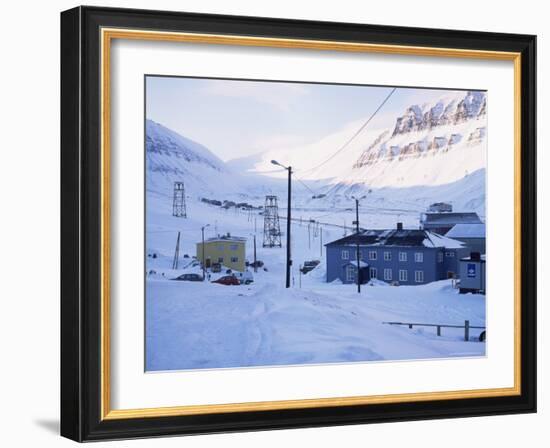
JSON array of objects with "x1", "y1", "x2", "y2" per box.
[{"x1": 235, "y1": 91, "x2": 487, "y2": 194}]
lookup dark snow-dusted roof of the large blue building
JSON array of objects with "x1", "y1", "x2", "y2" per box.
[{"x1": 325, "y1": 229, "x2": 463, "y2": 248}]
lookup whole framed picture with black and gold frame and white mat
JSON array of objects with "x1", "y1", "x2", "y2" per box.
[{"x1": 61, "y1": 7, "x2": 536, "y2": 441}]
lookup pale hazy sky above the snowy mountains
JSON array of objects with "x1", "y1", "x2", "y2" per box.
[{"x1": 146, "y1": 76, "x2": 462, "y2": 160}]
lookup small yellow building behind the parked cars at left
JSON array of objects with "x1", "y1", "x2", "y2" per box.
[{"x1": 197, "y1": 233, "x2": 246, "y2": 272}]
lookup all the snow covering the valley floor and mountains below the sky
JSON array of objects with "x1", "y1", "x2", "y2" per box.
[{"x1": 145, "y1": 87, "x2": 486, "y2": 371}]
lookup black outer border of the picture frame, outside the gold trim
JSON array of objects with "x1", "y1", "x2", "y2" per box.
[{"x1": 60, "y1": 6, "x2": 537, "y2": 442}]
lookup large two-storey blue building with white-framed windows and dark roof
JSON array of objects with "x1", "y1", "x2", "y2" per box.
[{"x1": 325, "y1": 224, "x2": 468, "y2": 285}]
